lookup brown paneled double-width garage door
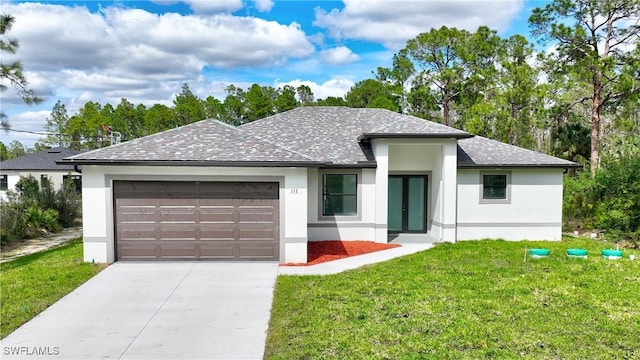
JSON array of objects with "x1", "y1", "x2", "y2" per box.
[{"x1": 113, "y1": 181, "x2": 280, "y2": 260}]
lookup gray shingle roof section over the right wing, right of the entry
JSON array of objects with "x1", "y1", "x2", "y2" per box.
[{"x1": 458, "y1": 136, "x2": 580, "y2": 168}]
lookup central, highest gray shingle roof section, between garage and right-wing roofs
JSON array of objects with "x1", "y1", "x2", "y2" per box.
[{"x1": 240, "y1": 106, "x2": 471, "y2": 165}]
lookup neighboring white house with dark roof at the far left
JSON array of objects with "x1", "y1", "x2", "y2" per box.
[{"x1": 0, "y1": 147, "x2": 82, "y2": 199}]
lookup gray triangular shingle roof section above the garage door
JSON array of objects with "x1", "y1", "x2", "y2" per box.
[{"x1": 67, "y1": 120, "x2": 320, "y2": 165}]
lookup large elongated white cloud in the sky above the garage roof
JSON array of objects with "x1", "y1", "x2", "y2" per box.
[{"x1": 106, "y1": 8, "x2": 314, "y2": 67}]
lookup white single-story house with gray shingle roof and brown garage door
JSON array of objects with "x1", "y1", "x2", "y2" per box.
[{"x1": 61, "y1": 107, "x2": 577, "y2": 263}]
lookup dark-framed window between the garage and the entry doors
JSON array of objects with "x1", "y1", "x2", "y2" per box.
[{"x1": 322, "y1": 174, "x2": 358, "y2": 216}]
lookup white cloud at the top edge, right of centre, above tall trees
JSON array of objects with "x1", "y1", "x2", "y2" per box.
[{"x1": 314, "y1": 0, "x2": 523, "y2": 49}]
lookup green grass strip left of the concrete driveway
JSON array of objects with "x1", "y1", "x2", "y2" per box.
[{"x1": 0, "y1": 239, "x2": 104, "y2": 338}]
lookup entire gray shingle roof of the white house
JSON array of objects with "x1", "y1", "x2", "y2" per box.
[{"x1": 64, "y1": 106, "x2": 576, "y2": 167}]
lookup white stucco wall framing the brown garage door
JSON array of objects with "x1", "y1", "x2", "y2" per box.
[{"x1": 82, "y1": 165, "x2": 308, "y2": 263}]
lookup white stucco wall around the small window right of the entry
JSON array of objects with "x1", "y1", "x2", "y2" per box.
[{"x1": 457, "y1": 169, "x2": 563, "y2": 240}]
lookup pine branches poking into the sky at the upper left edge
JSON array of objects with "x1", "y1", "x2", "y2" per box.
[{"x1": 0, "y1": 14, "x2": 42, "y2": 120}]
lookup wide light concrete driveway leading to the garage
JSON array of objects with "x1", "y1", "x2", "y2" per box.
[{"x1": 0, "y1": 262, "x2": 278, "y2": 359}]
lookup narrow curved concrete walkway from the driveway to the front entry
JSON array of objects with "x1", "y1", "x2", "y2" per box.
[{"x1": 278, "y1": 243, "x2": 434, "y2": 275}]
